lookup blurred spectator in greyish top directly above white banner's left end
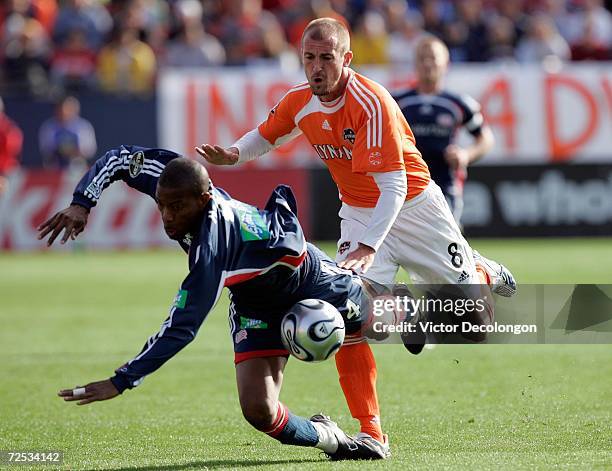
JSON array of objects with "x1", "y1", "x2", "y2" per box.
[{"x1": 165, "y1": 21, "x2": 225, "y2": 67}]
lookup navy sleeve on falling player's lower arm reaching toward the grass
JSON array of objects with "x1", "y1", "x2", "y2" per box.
[{"x1": 111, "y1": 243, "x2": 227, "y2": 392}]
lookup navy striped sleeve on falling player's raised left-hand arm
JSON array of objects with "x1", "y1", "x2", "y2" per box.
[{"x1": 72, "y1": 146, "x2": 180, "y2": 209}]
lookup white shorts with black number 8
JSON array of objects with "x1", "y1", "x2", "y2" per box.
[{"x1": 336, "y1": 182, "x2": 479, "y2": 284}]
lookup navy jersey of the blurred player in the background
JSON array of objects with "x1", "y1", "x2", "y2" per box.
[{"x1": 394, "y1": 89, "x2": 483, "y2": 194}]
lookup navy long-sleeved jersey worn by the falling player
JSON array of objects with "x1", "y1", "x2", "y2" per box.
[{"x1": 73, "y1": 146, "x2": 352, "y2": 391}]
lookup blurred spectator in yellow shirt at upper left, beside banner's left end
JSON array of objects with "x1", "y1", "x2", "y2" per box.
[{"x1": 97, "y1": 25, "x2": 156, "y2": 95}]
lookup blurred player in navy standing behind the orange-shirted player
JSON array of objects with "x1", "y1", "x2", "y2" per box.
[{"x1": 395, "y1": 36, "x2": 494, "y2": 223}]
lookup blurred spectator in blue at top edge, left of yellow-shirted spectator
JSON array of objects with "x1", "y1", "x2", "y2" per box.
[{"x1": 53, "y1": 0, "x2": 113, "y2": 50}]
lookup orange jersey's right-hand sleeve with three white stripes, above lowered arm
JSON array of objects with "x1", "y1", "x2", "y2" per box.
[{"x1": 352, "y1": 87, "x2": 406, "y2": 174}]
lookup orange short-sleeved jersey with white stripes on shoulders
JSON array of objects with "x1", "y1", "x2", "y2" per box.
[{"x1": 258, "y1": 71, "x2": 430, "y2": 207}]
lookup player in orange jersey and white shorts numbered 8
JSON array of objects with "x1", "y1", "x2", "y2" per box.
[{"x1": 196, "y1": 18, "x2": 514, "y2": 456}]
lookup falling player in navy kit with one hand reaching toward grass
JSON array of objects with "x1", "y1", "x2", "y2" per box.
[{"x1": 39, "y1": 146, "x2": 389, "y2": 460}]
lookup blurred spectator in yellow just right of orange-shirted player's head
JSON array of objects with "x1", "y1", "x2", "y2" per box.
[{"x1": 351, "y1": 11, "x2": 389, "y2": 66}]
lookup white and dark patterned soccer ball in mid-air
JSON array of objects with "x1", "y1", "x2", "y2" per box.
[{"x1": 281, "y1": 299, "x2": 344, "y2": 362}]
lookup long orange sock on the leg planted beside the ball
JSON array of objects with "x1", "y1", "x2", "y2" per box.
[{"x1": 336, "y1": 342, "x2": 383, "y2": 441}]
